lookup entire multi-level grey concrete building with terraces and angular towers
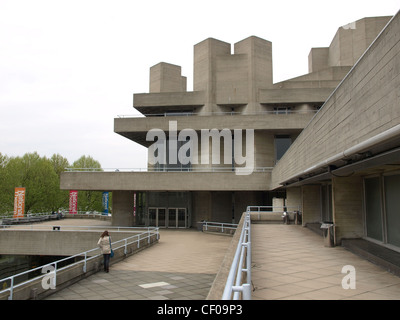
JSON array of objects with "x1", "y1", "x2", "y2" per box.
[{"x1": 61, "y1": 14, "x2": 400, "y2": 250}]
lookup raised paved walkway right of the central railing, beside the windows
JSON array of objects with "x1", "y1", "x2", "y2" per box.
[{"x1": 252, "y1": 224, "x2": 400, "y2": 300}]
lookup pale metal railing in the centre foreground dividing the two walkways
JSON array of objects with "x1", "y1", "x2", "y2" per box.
[{"x1": 222, "y1": 209, "x2": 251, "y2": 300}]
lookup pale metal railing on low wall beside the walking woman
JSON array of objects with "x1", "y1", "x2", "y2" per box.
[{"x1": 0, "y1": 226, "x2": 160, "y2": 300}]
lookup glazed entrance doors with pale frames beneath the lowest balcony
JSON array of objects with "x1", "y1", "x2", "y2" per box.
[{"x1": 149, "y1": 208, "x2": 188, "y2": 228}]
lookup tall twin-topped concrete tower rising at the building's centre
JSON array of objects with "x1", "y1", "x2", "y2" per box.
[{"x1": 193, "y1": 36, "x2": 272, "y2": 113}]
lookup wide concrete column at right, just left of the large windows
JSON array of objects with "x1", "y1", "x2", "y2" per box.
[{"x1": 332, "y1": 176, "x2": 364, "y2": 245}]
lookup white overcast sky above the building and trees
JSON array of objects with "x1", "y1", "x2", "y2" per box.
[{"x1": 0, "y1": 0, "x2": 400, "y2": 168}]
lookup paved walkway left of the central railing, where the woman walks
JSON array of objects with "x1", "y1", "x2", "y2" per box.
[{"x1": 47, "y1": 230, "x2": 232, "y2": 300}]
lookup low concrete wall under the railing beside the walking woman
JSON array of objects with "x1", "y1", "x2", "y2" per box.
[{"x1": 0, "y1": 234, "x2": 158, "y2": 300}]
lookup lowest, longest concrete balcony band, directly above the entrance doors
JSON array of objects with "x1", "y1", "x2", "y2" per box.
[{"x1": 60, "y1": 168, "x2": 271, "y2": 191}]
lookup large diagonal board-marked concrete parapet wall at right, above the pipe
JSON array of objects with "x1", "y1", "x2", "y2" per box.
[{"x1": 271, "y1": 15, "x2": 400, "y2": 188}]
